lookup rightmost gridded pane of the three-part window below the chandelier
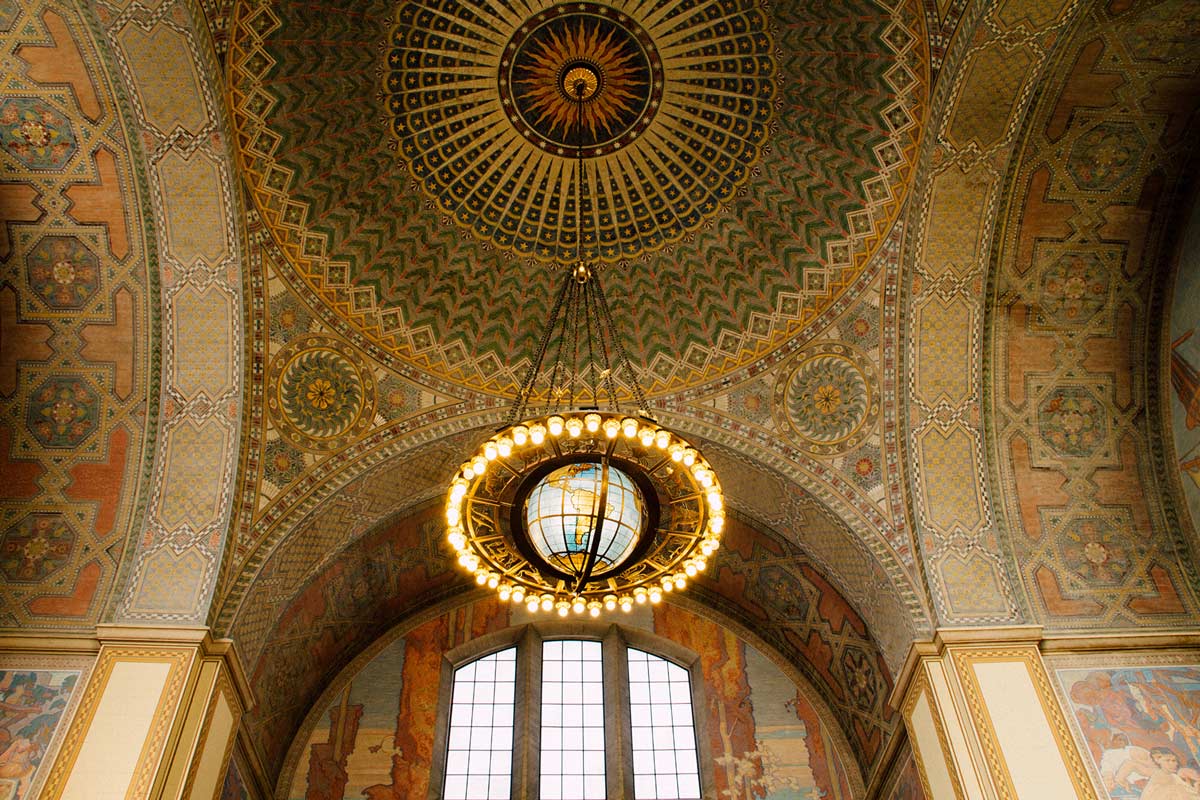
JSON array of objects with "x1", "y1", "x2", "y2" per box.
[{"x1": 628, "y1": 648, "x2": 700, "y2": 800}]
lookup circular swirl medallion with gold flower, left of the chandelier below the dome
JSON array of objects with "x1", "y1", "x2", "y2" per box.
[{"x1": 266, "y1": 337, "x2": 374, "y2": 451}]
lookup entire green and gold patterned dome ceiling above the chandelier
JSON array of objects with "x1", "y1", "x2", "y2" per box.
[{"x1": 230, "y1": 0, "x2": 928, "y2": 393}]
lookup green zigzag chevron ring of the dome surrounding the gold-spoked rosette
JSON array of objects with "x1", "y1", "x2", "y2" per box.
[{"x1": 229, "y1": 0, "x2": 928, "y2": 393}]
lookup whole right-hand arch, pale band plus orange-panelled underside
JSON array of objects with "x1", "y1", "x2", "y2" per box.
[{"x1": 905, "y1": 2, "x2": 1195, "y2": 628}]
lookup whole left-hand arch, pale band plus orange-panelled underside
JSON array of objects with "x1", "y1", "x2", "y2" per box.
[{"x1": 0, "y1": 0, "x2": 241, "y2": 628}]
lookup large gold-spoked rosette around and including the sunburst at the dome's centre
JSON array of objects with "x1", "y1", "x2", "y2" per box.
[{"x1": 385, "y1": 0, "x2": 776, "y2": 260}]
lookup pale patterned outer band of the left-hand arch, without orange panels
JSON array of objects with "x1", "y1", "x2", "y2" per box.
[{"x1": 94, "y1": 0, "x2": 244, "y2": 622}]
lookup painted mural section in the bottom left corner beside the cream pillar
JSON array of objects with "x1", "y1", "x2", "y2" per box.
[{"x1": 0, "y1": 669, "x2": 80, "y2": 800}]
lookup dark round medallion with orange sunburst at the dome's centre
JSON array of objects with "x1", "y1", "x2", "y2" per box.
[{"x1": 499, "y1": 2, "x2": 664, "y2": 157}]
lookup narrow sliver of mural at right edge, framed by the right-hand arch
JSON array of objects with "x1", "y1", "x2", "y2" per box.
[{"x1": 1170, "y1": 195, "x2": 1200, "y2": 537}]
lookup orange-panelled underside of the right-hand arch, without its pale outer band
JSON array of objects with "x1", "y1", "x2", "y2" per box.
[{"x1": 983, "y1": 2, "x2": 1200, "y2": 630}]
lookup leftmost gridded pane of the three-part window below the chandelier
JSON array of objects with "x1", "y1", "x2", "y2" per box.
[{"x1": 442, "y1": 648, "x2": 516, "y2": 800}]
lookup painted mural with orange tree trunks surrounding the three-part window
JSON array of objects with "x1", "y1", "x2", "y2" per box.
[{"x1": 284, "y1": 600, "x2": 852, "y2": 800}]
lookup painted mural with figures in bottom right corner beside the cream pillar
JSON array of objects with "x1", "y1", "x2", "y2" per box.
[{"x1": 1057, "y1": 666, "x2": 1200, "y2": 800}]
